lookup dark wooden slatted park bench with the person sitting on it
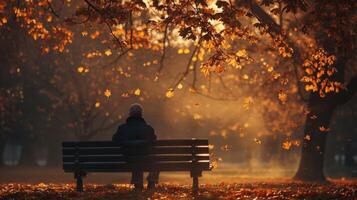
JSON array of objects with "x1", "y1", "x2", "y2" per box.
[{"x1": 62, "y1": 139, "x2": 211, "y2": 192}]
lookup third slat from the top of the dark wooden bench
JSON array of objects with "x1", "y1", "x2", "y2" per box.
[{"x1": 62, "y1": 154, "x2": 209, "y2": 162}]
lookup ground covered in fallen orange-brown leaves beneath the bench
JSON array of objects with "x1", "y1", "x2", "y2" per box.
[{"x1": 0, "y1": 181, "x2": 357, "y2": 200}]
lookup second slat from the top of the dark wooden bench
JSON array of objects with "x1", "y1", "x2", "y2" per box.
[{"x1": 62, "y1": 146, "x2": 209, "y2": 155}]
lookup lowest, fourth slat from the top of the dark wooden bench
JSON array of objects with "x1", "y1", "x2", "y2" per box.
[{"x1": 63, "y1": 161, "x2": 210, "y2": 172}]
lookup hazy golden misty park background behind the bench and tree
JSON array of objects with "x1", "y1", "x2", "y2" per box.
[{"x1": 0, "y1": 12, "x2": 357, "y2": 182}]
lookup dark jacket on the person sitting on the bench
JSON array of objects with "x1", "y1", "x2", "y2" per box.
[{"x1": 112, "y1": 117, "x2": 156, "y2": 142}]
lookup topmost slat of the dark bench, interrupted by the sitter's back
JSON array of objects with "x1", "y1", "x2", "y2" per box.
[{"x1": 62, "y1": 139, "x2": 208, "y2": 147}]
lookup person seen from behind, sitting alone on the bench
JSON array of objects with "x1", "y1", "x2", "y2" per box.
[{"x1": 112, "y1": 104, "x2": 159, "y2": 190}]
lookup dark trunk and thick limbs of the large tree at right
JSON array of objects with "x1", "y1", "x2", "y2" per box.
[{"x1": 245, "y1": 0, "x2": 357, "y2": 181}]
